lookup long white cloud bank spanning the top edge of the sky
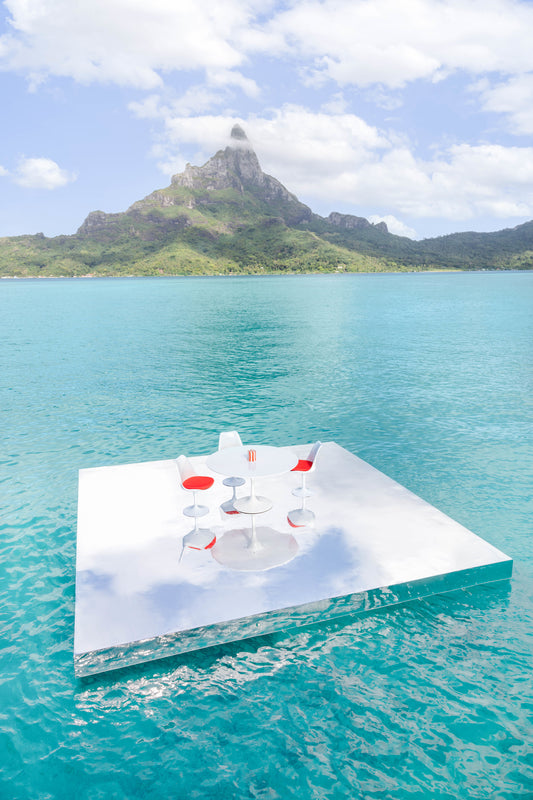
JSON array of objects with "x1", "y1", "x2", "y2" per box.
[{"x1": 4, "y1": 0, "x2": 533, "y2": 94}]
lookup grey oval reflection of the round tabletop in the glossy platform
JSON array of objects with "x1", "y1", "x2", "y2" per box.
[{"x1": 211, "y1": 526, "x2": 298, "y2": 572}]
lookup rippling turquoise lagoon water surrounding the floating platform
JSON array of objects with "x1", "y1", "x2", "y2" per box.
[{"x1": 0, "y1": 273, "x2": 533, "y2": 800}]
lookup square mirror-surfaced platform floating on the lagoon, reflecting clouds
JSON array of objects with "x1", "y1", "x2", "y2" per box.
[{"x1": 74, "y1": 442, "x2": 513, "y2": 677}]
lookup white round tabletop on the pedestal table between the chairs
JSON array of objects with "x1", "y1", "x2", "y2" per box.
[{"x1": 206, "y1": 444, "x2": 298, "y2": 478}]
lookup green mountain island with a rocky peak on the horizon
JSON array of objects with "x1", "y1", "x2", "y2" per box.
[{"x1": 0, "y1": 125, "x2": 533, "y2": 276}]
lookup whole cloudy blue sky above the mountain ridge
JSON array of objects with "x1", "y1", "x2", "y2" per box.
[{"x1": 0, "y1": 0, "x2": 533, "y2": 238}]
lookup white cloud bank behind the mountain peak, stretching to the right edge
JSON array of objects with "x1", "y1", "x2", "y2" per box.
[{"x1": 133, "y1": 101, "x2": 533, "y2": 225}]
